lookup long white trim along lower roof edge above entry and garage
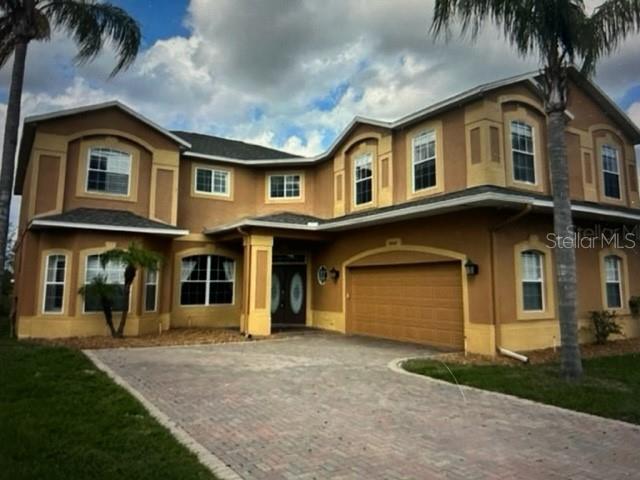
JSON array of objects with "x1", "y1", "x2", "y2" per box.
[{"x1": 204, "y1": 192, "x2": 640, "y2": 234}]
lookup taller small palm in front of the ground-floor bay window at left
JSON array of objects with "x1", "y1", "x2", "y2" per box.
[{"x1": 100, "y1": 242, "x2": 162, "y2": 337}]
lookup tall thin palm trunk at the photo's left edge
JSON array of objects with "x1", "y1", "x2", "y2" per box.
[{"x1": 0, "y1": 40, "x2": 28, "y2": 270}]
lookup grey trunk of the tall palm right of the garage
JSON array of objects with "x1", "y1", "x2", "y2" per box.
[{"x1": 547, "y1": 109, "x2": 582, "y2": 379}]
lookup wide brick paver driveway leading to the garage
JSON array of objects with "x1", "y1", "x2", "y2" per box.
[{"x1": 95, "y1": 334, "x2": 640, "y2": 480}]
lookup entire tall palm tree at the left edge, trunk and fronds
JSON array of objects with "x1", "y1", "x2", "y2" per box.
[{"x1": 0, "y1": 0, "x2": 141, "y2": 278}]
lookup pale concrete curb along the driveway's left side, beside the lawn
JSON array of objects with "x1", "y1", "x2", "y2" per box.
[{"x1": 82, "y1": 350, "x2": 242, "y2": 480}]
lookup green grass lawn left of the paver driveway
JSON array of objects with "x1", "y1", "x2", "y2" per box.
[{"x1": 0, "y1": 318, "x2": 214, "y2": 480}]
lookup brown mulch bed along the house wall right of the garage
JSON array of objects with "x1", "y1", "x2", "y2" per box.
[{"x1": 435, "y1": 337, "x2": 640, "y2": 365}]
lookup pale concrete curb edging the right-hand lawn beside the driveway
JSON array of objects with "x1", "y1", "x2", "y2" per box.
[{"x1": 387, "y1": 357, "x2": 640, "y2": 432}]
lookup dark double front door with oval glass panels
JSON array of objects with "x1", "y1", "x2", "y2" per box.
[{"x1": 271, "y1": 265, "x2": 307, "y2": 325}]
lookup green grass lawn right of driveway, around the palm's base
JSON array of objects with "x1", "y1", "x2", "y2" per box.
[{"x1": 404, "y1": 353, "x2": 640, "y2": 424}]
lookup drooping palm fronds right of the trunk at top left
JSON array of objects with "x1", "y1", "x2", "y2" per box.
[{"x1": 40, "y1": 0, "x2": 141, "y2": 76}]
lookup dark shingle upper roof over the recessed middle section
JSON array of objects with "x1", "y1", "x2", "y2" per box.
[{"x1": 171, "y1": 130, "x2": 298, "y2": 160}]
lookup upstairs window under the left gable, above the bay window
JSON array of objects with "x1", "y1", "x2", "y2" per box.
[{"x1": 87, "y1": 148, "x2": 131, "y2": 195}]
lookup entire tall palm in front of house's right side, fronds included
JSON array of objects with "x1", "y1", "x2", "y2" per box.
[{"x1": 431, "y1": 0, "x2": 640, "y2": 379}]
